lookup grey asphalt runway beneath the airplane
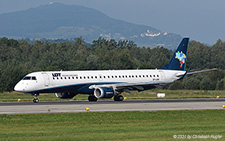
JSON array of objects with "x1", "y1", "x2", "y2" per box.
[{"x1": 0, "y1": 98, "x2": 225, "y2": 114}]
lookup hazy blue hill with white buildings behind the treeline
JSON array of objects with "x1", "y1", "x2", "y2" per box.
[{"x1": 0, "y1": 3, "x2": 181, "y2": 49}]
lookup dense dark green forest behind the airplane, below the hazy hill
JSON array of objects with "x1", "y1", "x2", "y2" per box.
[{"x1": 0, "y1": 38, "x2": 225, "y2": 91}]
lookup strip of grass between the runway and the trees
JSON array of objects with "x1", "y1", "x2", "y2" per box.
[{"x1": 0, "y1": 89, "x2": 225, "y2": 101}]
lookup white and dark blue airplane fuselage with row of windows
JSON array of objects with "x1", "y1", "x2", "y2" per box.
[{"x1": 15, "y1": 69, "x2": 185, "y2": 94}]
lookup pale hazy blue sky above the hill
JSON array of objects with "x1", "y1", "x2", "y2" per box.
[{"x1": 0, "y1": 0, "x2": 225, "y2": 45}]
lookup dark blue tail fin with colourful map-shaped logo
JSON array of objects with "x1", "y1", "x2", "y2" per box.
[{"x1": 161, "y1": 38, "x2": 189, "y2": 70}]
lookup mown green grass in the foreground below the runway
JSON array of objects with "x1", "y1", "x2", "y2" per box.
[{"x1": 0, "y1": 110, "x2": 225, "y2": 141}]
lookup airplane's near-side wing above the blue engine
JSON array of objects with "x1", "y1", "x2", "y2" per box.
[{"x1": 89, "y1": 80, "x2": 173, "y2": 93}]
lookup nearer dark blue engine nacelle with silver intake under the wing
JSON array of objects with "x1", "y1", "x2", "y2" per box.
[{"x1": 94, "y1": 87, "x2": 115, "y2": 98}]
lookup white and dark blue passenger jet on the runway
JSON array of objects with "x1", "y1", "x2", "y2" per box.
[{"x1": 14, "y1": 38, "x2": 215, "y2": 103}]
